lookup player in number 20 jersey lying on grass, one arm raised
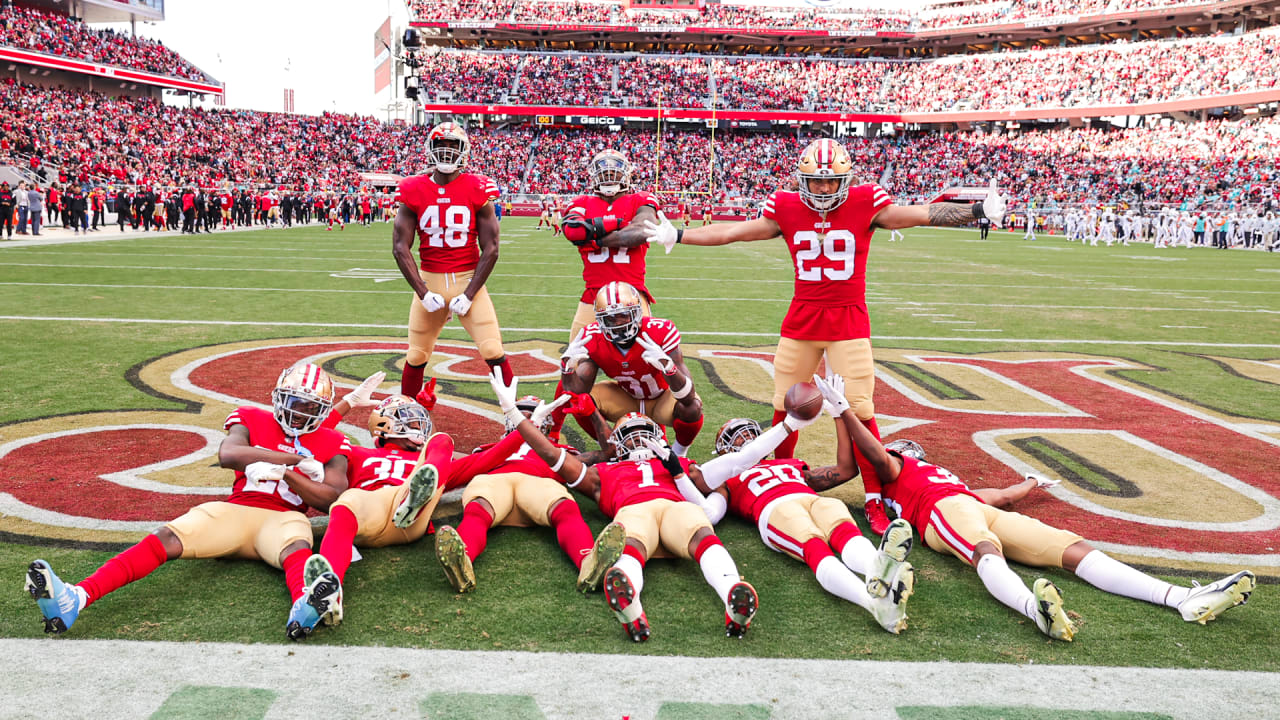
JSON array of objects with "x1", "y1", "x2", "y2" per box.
[{"x1": 655, "y1": 375, "x2": 915, "y2": 634}]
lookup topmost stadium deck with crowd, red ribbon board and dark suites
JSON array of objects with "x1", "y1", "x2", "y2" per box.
[{"x1": 410, "y1": 0, "x2": 1280, "y2": 58}]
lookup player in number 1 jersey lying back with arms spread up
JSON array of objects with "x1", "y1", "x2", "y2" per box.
[{"x1": 489, "y1": 366, "x2": 813, "y2": 642}]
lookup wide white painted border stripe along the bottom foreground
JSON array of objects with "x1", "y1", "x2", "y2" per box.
[{"x1": 0, "y1": 635, "x2": 1280, "y2": 720}]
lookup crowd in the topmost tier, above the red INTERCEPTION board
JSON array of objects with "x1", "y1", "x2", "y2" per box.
[{"x1": 412, "y1": 0, "x2": 1216, "y2": 32}]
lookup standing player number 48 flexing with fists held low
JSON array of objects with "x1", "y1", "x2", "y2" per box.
[{"x1": 392, "y1": 123, "x2": 512, "y2": 397}]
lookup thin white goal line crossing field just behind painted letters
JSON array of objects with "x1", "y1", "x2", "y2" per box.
[{"x1": 0, "y1": 315, "x2": 1280, "y2": 350}]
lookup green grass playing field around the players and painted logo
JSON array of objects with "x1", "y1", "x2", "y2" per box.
[{"x1": 0, "y1": 219, "x2": 1280, "y2": 671}]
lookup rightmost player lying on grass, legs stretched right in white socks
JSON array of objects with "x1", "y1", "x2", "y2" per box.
[{"x1": 814, "y1": 368, "x2": 1254, "y2": 641}]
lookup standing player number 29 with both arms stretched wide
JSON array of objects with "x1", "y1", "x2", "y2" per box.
[{"x1": 646, "y1": 138, "x2": 1006, "y2": 534}]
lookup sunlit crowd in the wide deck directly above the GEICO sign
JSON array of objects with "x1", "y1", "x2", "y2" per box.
[{"x1": 422, "y1": 31, "x2": 1280, "y2": 113}]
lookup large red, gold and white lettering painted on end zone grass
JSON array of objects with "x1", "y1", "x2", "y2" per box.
[{"x1": 0, "y1": 338, "x2": 1280, "y2": 575}]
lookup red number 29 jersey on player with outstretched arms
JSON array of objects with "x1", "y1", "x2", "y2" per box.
[{"x1": 763, "y1": 183, "x2": 893, "y2": 341}]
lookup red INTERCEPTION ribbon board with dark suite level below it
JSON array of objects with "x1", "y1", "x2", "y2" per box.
[{"x1": 410, "y1": 0, "x2": 1280, "y2": 58}]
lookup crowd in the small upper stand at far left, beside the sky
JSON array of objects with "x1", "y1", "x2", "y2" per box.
[{"x1": 0, "y1": 4, "x2": 209, "y2": 82}]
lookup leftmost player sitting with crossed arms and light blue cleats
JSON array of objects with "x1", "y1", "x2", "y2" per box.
[{"x1": 26, "y1": 363, "x2": 351, "y2": 639}]
